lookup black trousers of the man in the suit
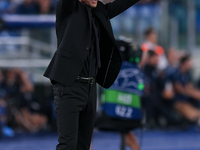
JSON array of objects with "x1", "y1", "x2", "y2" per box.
[{"x1": 53, "y1": 81, "x2": 96, "y2": 150}]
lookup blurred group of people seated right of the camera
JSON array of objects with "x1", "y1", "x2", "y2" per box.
[{"x1": 142, "y1": 28, "x2": 200, "y2": 127}]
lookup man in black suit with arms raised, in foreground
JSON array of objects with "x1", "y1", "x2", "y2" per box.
[{"x1": 44, "y1": 0, "x2": 139, "y2": 150}]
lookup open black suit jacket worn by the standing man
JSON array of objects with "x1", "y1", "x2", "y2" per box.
[{"x1": 44, "y1": 0, "x2": 139, "y2": 88}]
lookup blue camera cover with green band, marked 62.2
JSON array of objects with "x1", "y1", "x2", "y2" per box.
[{"x1": 101, "y1": 62, "x2": 144, "y2": 120}]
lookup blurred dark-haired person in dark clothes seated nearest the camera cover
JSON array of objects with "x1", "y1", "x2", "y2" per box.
[{"x1": 142, "y1": 50, "x2": 176, "y2": 128}]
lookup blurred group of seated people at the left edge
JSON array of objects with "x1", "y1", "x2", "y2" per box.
[{"x1": 0, "y1": 68, "x2": 51, "y2": 136}]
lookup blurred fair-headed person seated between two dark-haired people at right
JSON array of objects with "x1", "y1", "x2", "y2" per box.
[{"x1": 153, "y1": 48, "x2": 184, "y2": 127}]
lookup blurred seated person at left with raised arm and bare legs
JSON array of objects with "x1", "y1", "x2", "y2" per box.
[{"x1": 3, "y1": 69, "x2": 47, "y2": 132}]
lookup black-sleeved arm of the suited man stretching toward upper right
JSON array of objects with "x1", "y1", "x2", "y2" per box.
[{"x1": 105, "y1": 0, "x2": 140, "y2": 19}]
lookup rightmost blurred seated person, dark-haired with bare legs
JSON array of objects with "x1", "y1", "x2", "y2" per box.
[{"x1": 173, "y1": 55, "x2": 200, "y2": 124}]
